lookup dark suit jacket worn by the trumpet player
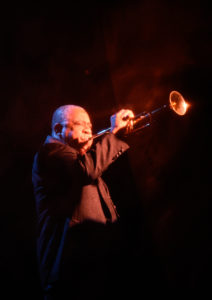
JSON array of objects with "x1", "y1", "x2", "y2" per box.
[{"x1": 32, "y1": 133, "x2": 129, "y2": 288}]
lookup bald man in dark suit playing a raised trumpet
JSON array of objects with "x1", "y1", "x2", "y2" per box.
[{"x1": 32, "y1": 105, "x2": 134, "y2": 299}]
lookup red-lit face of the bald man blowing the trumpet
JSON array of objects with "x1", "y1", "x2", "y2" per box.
[{"x1": 61, "y1": 108, "x2": 93, "y2": 154}]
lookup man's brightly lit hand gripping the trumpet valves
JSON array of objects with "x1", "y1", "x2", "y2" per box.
[{"x1": 110, "y1": 109, "x2": 134, "y2": 134}]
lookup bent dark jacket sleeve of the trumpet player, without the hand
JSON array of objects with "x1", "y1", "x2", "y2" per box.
[{"x1": 44, "y1": 133, "x2": 129, "y2": 181}]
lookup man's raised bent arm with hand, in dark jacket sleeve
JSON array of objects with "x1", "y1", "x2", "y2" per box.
[{"x1": 45, "y1": 109, "x2": 134, "y2": 180}]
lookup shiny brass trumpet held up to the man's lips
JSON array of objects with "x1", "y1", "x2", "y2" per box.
[{"x1": 91, "y1": 91, "x2": 188, "y2": 139}]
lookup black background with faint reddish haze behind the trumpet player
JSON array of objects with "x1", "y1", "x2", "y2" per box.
[{"x1": 0, "y1": 0, "x2": 212, "y2": 299}]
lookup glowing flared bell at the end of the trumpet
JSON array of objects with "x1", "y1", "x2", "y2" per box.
[{"x1": 169, "y1": 91, "x2": 187, "y2": 116}]
